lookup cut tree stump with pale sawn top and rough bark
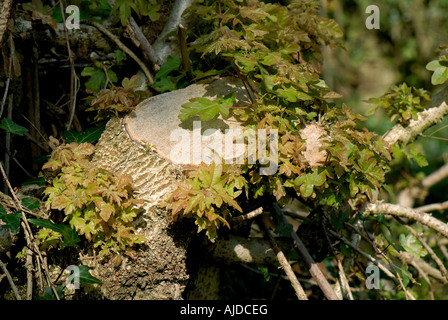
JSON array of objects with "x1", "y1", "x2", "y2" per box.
[{"x1": 93, "y1": 78, "x2": 247, "y2": 299}]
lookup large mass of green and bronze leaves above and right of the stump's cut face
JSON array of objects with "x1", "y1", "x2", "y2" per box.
[{"x1": 166, "y1": 0, "x2": 391, "y2": 240}]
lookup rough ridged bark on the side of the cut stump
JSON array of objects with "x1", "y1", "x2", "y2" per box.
[{"x1": 94, "y1": 119, "x2": 191, "y2": 300}]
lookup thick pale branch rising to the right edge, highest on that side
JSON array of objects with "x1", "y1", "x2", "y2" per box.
[{"x1": 384, "y1": 88, "x2": 448, "y2": 145}]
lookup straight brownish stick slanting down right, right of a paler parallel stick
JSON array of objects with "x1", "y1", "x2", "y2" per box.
[{"x1": 273, "y1": 202, "x2": 339, "y2": 300}]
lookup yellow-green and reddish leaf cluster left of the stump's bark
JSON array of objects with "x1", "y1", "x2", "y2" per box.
[{"x1": 41, "y1": 142, "x2": 143, "y2": 255}]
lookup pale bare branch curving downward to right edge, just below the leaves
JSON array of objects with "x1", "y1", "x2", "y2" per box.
[{"x1": 361, "y1": 202, "x2": 448, "y2": 238}]
